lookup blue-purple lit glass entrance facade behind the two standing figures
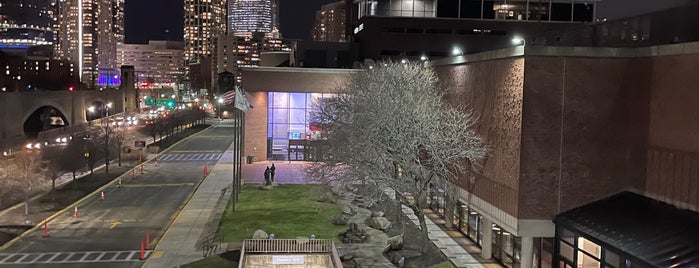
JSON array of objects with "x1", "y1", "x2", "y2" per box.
[{"x1": 267, "y1": 92, "x2": 336, "y2": 161}]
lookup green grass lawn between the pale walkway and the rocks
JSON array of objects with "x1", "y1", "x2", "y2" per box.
[{"x1": 219, "y1": 184, "x2": 347, "y2": 242}]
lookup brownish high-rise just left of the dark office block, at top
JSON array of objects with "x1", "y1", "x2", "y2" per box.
[{"x1": 311, "y1": 1, "x2": 347, "y2": 42}]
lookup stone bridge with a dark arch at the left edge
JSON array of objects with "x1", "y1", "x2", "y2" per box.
[{"x1": 0, "y1": 88, "x2": 135, "y2": 148}]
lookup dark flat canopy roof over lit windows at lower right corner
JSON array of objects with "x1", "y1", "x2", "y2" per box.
[{"x1": 554, "y1": 192, "x2": 699, "y2": 267}]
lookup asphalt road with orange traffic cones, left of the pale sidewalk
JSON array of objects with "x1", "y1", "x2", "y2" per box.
[{"x1": 0, "y1": 121, "x2": 233, "y2": 267}]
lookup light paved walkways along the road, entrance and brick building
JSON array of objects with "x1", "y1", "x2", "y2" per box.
[{"x1": 143, "y1": 158, "x2": 502, "y2": 268}]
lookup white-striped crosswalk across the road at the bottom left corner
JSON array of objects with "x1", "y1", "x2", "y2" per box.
[{"x1": 0, "y1": 250, "x2": 151, "y2": 266}]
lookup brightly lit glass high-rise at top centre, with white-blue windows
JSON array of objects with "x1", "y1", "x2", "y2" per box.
[{"x1": 228, "y1": 0, "x2": 279, "y2": 38}]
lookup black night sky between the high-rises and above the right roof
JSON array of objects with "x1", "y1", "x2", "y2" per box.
[{"x1": 125, "y1": 0, "x2": 688, "y2": 44}]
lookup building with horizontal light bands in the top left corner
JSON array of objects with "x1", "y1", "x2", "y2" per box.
[{"x1": 0, "y1": 0, "x2": 56, "y2": 48}]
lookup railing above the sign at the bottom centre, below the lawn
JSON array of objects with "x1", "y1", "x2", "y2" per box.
[{"x1": 238, "y1": 238, "x2": 342, "y2": 268}]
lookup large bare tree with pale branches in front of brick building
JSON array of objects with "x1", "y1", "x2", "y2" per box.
[{"x1": 308, "y1": 62, "x2": 488, "y2": 253}]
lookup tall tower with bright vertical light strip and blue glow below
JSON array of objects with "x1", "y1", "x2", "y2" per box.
[{"x1": 55, "y1": 0, "x2": 124, "y2": 86}]
